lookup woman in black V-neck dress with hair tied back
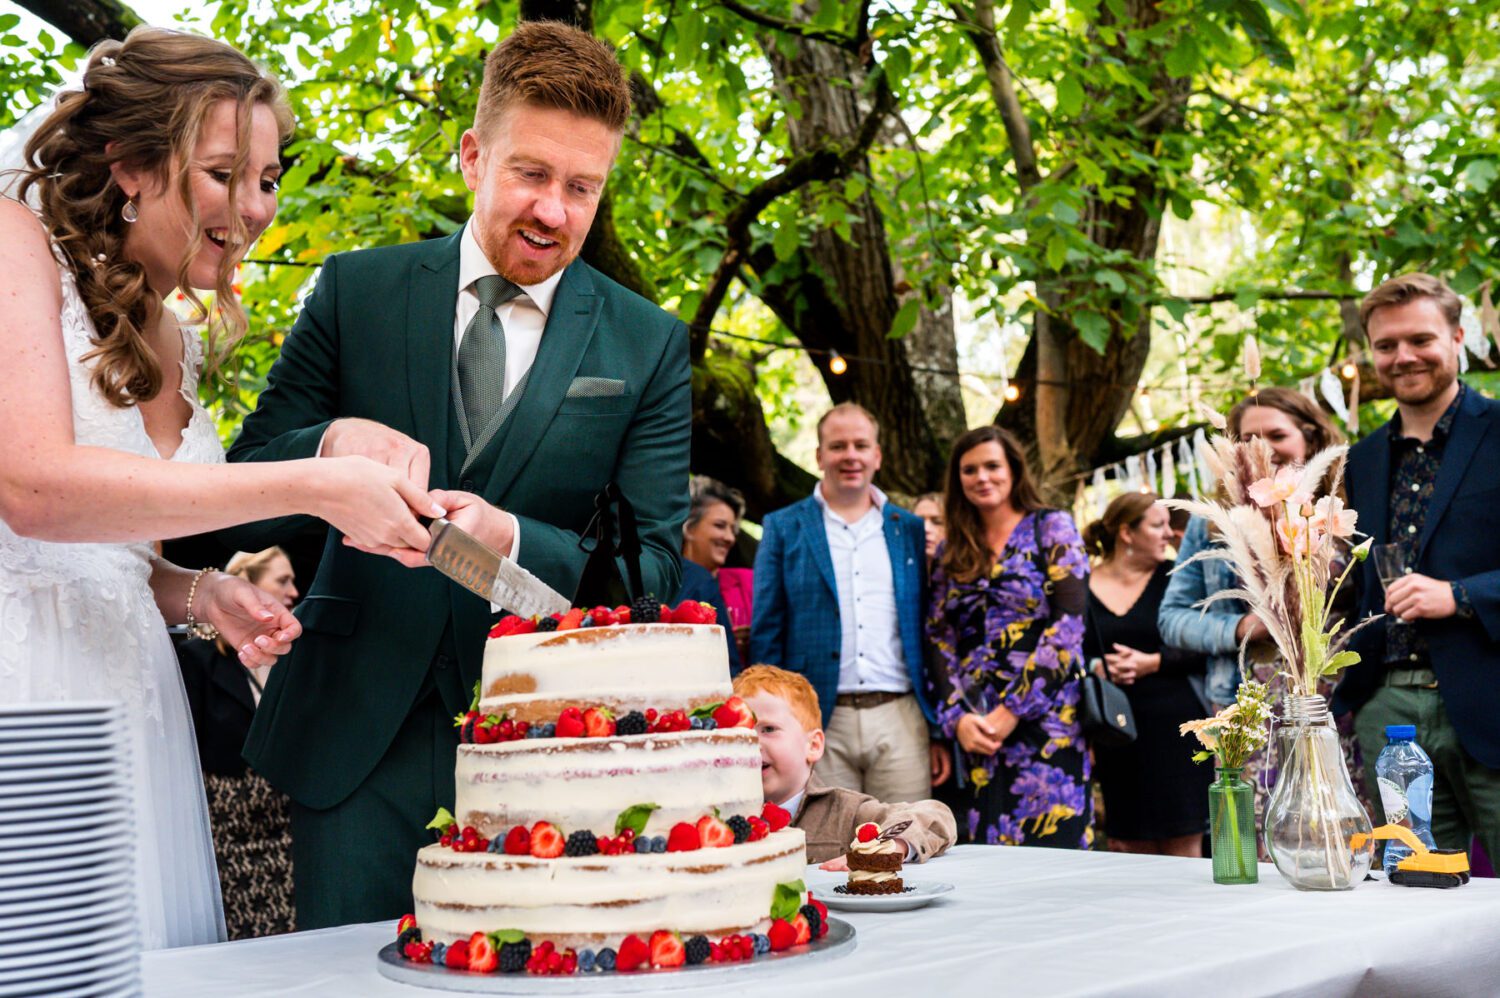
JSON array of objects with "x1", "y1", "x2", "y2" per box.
[{"x1": 1083, "y1": 492, "x2": 1214, "y2": 857}]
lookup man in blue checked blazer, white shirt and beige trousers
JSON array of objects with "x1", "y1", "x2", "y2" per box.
[{"x1": 750, "y1": 402, "x2": 948, "y2": 800}]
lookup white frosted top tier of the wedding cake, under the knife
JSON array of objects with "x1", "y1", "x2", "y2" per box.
[{"x1": 480, "y1": 624, "x2": 731, "y2": 713}]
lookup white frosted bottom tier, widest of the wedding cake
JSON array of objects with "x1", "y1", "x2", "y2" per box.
[{"x1": 411, "y1": 828, "x2": 807, "y2": 947}]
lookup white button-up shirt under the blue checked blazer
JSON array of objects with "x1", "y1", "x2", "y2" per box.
[{"x1": 813, "y1": 482, "x2": 912, "y2": 693}]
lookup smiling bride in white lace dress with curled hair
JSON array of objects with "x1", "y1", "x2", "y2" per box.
[{"x1": 0, "y1": 29, "x2": 434, "y2": 948}]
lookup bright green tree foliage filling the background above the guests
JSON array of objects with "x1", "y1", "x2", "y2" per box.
[{"x1": 0, "y1": 0, "x2": 1500, "y2": 450}]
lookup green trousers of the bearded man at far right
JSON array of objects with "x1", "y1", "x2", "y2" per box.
[{"x1": 1355, "y1": 686, "x2": 1500, "y2": 863}]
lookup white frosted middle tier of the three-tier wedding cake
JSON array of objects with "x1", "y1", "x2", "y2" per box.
[{"x1": 455, "y1": 728, "x2": 764, "y2": 837}]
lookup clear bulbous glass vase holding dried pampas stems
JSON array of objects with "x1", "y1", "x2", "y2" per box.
[{"x1": 1266, "y1": 693, "x2": 1374, "y2": 890}]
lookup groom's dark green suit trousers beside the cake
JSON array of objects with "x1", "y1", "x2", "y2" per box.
[{"x1": 291, "y1": 681, "x2": 458, "y2": 929}]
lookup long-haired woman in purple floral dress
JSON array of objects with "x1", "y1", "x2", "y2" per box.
[{"x1": 927, "y1": 426, "x2": 1094, "y2": 849}]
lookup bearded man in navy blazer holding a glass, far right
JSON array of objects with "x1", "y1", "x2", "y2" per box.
[{"x1": 1335, "y1": 273, "x2": 1500, "y2": 860}]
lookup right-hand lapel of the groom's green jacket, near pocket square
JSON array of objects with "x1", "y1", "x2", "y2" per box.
[{"x1": 480, "y1": 261, "x2": 602, "y2": 504}]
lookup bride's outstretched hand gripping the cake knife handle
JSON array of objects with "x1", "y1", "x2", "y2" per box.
[{"x1": 314, "y1": 456, "x2": 444, "y2": 554}]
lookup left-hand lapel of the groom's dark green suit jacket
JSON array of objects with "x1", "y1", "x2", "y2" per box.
[{"x1": 407, "y1": 236, "x2": 459, "y2": 476}]
